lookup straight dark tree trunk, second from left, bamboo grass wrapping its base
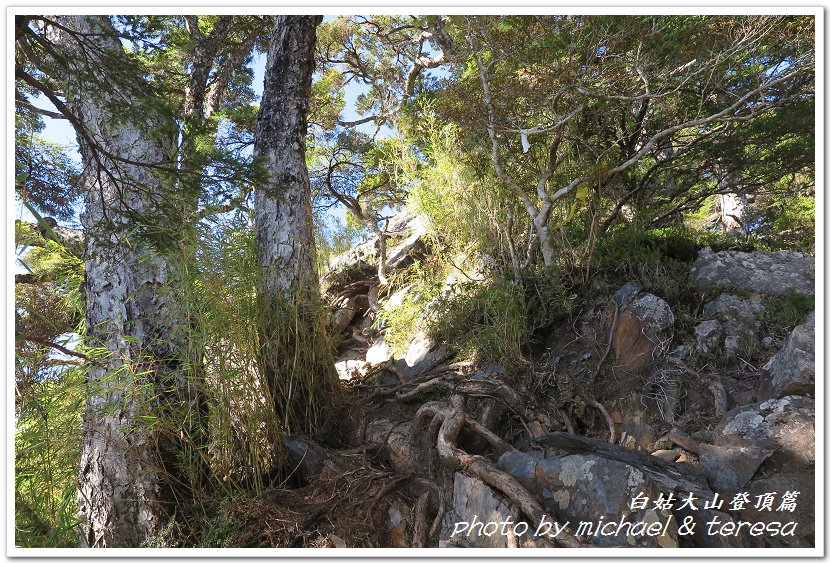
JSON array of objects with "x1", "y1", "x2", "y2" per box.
[{"x1": 254, "y1": 16, "x2": 334, "y2": 432}]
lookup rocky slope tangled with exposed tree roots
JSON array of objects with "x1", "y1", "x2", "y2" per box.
[{"x1": 242, "y1": 209, "x2": 815, "y2": 548}]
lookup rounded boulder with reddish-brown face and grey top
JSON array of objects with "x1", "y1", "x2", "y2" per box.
[{"x1": 613, "y1": 290, "x2": 674, "y2": 373}]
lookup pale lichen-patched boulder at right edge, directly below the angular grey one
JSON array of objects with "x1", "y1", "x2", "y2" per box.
[{"x1": 713, "y1": 395, "x2": 816, "y2": 471}]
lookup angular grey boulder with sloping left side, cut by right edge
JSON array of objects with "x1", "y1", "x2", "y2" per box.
[{"x1": 759, "y1": 323, "x2": 816, "y2": 401}]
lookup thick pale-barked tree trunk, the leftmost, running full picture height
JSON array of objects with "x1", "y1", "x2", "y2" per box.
[{"x1": 45, "y1": 16, "x2": 188, "y2": 547}]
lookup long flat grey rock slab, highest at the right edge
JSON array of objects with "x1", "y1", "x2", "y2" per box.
[{"x1": 690, "y1": 247, "x2": 815, "y2": 295}]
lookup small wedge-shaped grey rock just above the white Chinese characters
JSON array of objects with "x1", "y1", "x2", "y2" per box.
[{"x1": 700, "y1": 444, "x2": 770, "y2": 493}]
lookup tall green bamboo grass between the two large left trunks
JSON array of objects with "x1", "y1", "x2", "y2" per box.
[{"x1": 178, "y1": 213, "x2": 282, "y2": 492}]
